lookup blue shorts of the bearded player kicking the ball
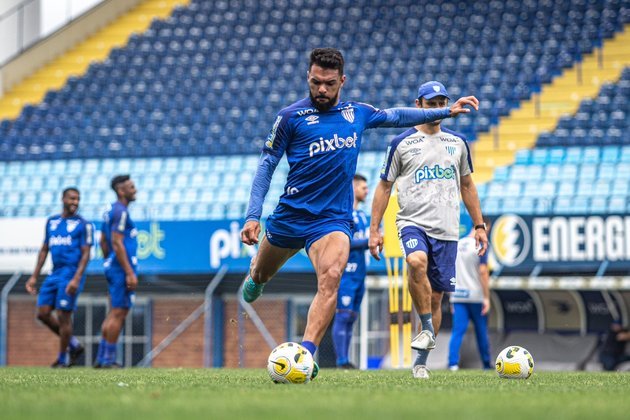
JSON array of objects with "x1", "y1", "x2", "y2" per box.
[{"x1": 265, "y1": 211, "x2": 352, "y2": 253}]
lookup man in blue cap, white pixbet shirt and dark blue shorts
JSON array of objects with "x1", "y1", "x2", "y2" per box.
[{"x1": 369, "y1": 81, "x2": 488, "y2": 379}]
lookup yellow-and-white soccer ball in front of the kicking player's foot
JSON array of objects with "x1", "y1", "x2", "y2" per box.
[{"x1": 267, "y1": 342, "x2": 313, "y2": 384}]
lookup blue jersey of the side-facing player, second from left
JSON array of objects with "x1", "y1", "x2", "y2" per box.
[{"x1": 102, "y1": 201, "x2": 138, "y2": 271}]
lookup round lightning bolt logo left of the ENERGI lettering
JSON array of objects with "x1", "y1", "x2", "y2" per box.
[{"x1": 492, "y1": 214, "x2": 531, "y2": 267}]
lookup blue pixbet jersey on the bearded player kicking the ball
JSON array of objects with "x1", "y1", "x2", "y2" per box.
[{"x1": 263, "y1": 98, "x2": 387, "y2": 221}]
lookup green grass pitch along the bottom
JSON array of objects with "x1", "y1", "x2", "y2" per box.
[{"x1": 0, "y1": 367, "x2": 630, "y2": 420}]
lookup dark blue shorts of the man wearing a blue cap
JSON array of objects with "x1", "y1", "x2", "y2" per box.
[{"x1": 399, "y1": 226, "x2": 457, "y2": 292}]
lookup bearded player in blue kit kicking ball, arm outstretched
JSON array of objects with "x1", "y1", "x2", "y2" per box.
[{"x1": 241, "y1": 48, "x2": 478, "y2": 375}]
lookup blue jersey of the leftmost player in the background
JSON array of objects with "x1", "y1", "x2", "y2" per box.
[{"x1": 44, "y1": 215, "x2": 93, "y2": 271}]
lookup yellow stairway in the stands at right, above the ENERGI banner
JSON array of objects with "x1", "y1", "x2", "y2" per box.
[{"x1": 474, "y1": 25, "x2": 630, "y2": 183}]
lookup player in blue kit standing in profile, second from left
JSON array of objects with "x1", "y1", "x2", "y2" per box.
[{"x1": 94, "y1": 175, "x2": 138, "y2": 368}]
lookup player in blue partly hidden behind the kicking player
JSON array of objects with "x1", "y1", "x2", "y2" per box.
[{"x1": 332, "y1": 174, "x2": 369, "y2": 369}]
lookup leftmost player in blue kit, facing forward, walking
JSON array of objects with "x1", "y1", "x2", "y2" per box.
[{"x1": 26, "y1": 188, "x2": 93, "y2": 368}]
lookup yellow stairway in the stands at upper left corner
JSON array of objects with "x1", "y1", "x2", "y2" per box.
[{"x1": 0, "y1": 0, "x2": 190, "y2": 120}]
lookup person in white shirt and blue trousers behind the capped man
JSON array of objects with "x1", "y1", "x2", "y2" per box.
[{"x1": 448, "y1": 221, "x2": 492, "y2": 370}]
